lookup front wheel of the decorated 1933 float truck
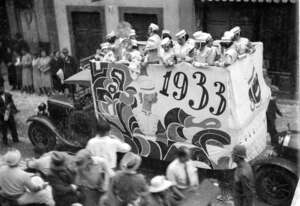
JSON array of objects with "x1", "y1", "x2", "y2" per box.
[{"x1": 28, "y1": 122, "x2": 56, "y2": 151}]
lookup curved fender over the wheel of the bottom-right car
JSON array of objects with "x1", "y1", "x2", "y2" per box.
[{"x1": 252, "y1": 156, "x2": 299, "y2": 177}]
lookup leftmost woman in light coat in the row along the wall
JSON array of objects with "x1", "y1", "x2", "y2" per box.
[{"x1": 21, "y1": 48, "x2": 33, "y2": 93}]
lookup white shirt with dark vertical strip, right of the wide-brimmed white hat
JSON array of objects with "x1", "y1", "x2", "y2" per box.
[{"x1": 167, "y1": 158, "x2": 199, "y2": 189}]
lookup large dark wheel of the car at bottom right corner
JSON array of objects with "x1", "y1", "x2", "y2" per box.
[{"x1": 256, "y1": 166, "x2": 297, "y2": 205}]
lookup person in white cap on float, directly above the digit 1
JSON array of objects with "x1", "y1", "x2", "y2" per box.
[{"x1": 160, "y1": 37, "x2": 176, "y2": 67}]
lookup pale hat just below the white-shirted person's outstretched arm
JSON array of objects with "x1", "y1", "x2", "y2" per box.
[{"x1": 120, "y1": 152, "x2": 142, "y2": 173}]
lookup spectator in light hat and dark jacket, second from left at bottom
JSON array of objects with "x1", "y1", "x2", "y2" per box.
[{"x1": 48, "y1": 152, "x2": 81, "y2": 206}]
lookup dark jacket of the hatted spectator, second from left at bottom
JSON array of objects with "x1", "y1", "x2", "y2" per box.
[{"x1": 48, "y1": 169, "x2": 79, "y2": 206}]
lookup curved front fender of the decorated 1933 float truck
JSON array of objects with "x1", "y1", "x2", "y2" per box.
[{"x1": 26, "y1": 115, "x2": 74, "y2": 146}]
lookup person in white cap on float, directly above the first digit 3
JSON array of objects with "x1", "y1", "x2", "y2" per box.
[{"x1": 193, "y1": 31, "x2": 215, "y2": 67}]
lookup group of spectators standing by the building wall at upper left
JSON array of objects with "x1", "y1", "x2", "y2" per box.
[{"x1": 0, "y1": 33, "x2": 78, "y2": 96}]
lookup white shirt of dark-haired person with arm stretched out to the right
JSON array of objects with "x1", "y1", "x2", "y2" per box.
[{"x1": 86, "y1": 136, "x2": 131, "y2": 169}]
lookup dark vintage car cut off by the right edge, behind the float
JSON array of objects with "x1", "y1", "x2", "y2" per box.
[{"x1": 253, "y1": 126, "x2": 300, "y2": 205}]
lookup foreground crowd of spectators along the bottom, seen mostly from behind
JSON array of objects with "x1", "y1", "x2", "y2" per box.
[{"x1": 0, "y1": 121, "x2": 254, "y2": 206}]
